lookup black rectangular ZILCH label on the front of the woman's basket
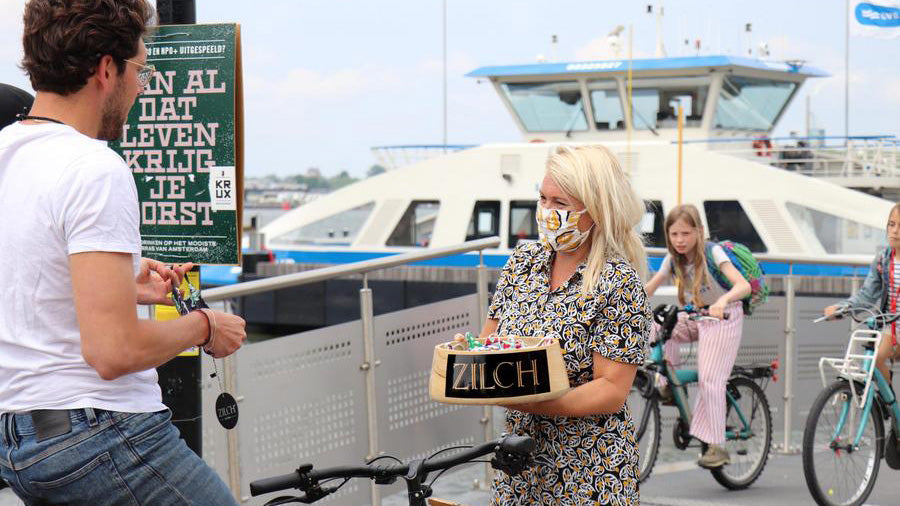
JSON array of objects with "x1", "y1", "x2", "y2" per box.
[{"x1": 444, "y1": 350, "x2": 550, "y2": 399}]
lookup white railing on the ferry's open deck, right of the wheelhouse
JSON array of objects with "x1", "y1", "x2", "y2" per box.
[{"x1": 686, "y1": 135, "x2": 900, "y2": 182}]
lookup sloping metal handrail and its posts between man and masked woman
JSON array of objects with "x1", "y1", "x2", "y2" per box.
[{"x1": 203, "y1": 237, "x2": 500, "y2": 506}]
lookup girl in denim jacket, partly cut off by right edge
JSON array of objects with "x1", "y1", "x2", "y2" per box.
[{"x1": 825, "y1": 203, "x2": 900, "y2": 384}]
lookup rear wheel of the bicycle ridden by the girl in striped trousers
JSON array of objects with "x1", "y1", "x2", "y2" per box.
[{"x1": 710, "y1": 376, "x2": 772, "y2": 490}]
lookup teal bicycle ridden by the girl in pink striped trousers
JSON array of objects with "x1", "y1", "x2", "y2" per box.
[{"x1": 628, "y1": 305, "x2": 774, "y2": 490}]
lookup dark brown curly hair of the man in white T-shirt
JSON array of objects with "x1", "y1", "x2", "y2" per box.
[{"x1": 22, "y1": 0, "x2": 154, "y2": 95}]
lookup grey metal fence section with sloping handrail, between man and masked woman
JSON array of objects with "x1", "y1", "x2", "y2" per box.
[{"x1": 202, "y1": 237, "x2": 500, "y2": 505}]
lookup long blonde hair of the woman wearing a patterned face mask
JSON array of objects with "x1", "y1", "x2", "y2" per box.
[{"x1": 547, "y1": 145, "x2": 647, "y2": 295}]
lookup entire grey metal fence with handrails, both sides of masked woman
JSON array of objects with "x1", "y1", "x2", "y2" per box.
[{"x1": 202, "y1": 238, "x2": 870, "y2": 505}]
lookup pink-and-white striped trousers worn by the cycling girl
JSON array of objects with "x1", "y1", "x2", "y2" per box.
[{"x1": 653, "y1": 301, "x2": 744, "y2": 445}]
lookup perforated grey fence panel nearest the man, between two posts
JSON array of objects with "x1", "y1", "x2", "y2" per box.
[{"x1": 230, "y1": 321, "x2": 369, "y2": 504}]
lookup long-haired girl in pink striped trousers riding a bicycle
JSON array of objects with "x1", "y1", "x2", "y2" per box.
[{"x1": 645, "y1": 204, "x2": 751, "y2": 469}]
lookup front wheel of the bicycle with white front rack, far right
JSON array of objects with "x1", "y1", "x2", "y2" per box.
[{"x1": 803, "y1": 380, "x2": 884, "y2": 506}]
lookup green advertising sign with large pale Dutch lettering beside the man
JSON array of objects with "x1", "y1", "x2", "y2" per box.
[{"x1": 111, "y1": 24, "x2": 243, "y2": 265}]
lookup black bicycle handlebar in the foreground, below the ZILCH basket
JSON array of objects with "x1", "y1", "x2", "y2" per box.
[{"x1": 250, "y1": 435, "x2": 535, "y2": 496}]
